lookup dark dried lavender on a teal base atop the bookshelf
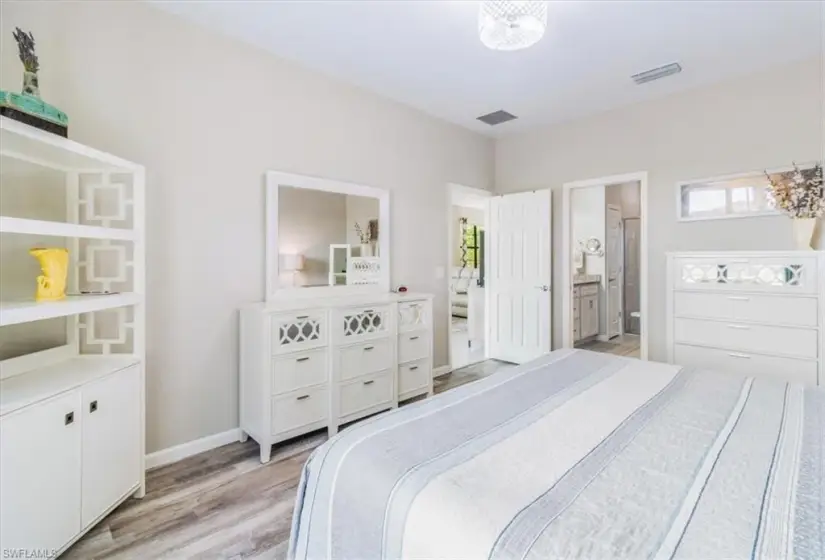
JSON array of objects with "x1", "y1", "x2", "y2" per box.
[{"x1": 0, "y1": 27, "x2": 69, "y2": 138}]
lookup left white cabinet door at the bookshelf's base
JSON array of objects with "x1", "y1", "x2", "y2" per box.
[{"x1": 0, "y1": 391, "x2": 81, "y2": 554}]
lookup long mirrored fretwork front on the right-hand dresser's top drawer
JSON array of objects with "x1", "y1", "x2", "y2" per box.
[{"x1": 682, "y1": 262, "x2": 805, "y2": 286}]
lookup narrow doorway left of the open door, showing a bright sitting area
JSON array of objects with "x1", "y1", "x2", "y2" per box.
[{"x1": 447, "y1": 184, "x2": 492, "y2": 370}]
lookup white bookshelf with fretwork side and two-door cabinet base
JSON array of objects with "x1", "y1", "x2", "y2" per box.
[{"x1": 0, "y1": 117, "x2": 146, "y2": 554}]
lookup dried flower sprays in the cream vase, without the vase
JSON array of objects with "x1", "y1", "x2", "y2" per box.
[{"x1": 765, "y1": 164, "x2": 825, "y2": 218}]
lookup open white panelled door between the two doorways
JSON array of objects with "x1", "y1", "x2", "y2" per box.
[{"x1": 486, "y1": 190, "x2": 552, "y2": 363}]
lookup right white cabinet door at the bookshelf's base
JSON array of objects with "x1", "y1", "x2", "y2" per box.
[{"x1": 81, "y1": 366, "x2": 140, "y2": 527}]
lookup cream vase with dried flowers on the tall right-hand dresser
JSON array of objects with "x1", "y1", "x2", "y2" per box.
[{"x1": 765, "y1": 164, "x2": 825, "y2": 250}]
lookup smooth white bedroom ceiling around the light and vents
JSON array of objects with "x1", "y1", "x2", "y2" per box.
[{"x1": 156, "y1": 0, "x2": 825, "y2": 136}]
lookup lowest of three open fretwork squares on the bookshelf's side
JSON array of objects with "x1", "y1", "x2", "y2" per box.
[{"x1": 78, "y1": 307, "x2": 135, "y2": 354}]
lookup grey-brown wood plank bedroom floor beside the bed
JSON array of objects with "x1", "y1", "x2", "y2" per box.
[{"x1": 63, "y1": 360, "x2": 512, "y2": 560}]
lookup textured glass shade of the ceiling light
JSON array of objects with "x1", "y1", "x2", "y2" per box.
[{"x1": 478, "y1": 0, "x2": 547, "y2": 51}]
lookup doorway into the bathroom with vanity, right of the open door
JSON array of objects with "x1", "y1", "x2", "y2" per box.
[{"x1": 562, "y1": 173, "x2": 648, "y2": 359}]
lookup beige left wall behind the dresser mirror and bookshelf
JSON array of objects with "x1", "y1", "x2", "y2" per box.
[{"x1": 0, "y1": 2, "x2": 493, "y2": 452}]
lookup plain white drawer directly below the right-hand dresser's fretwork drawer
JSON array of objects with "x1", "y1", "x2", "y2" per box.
[{"x1": 673, "y1": 292, "x2": 819, "y2": 327}]
